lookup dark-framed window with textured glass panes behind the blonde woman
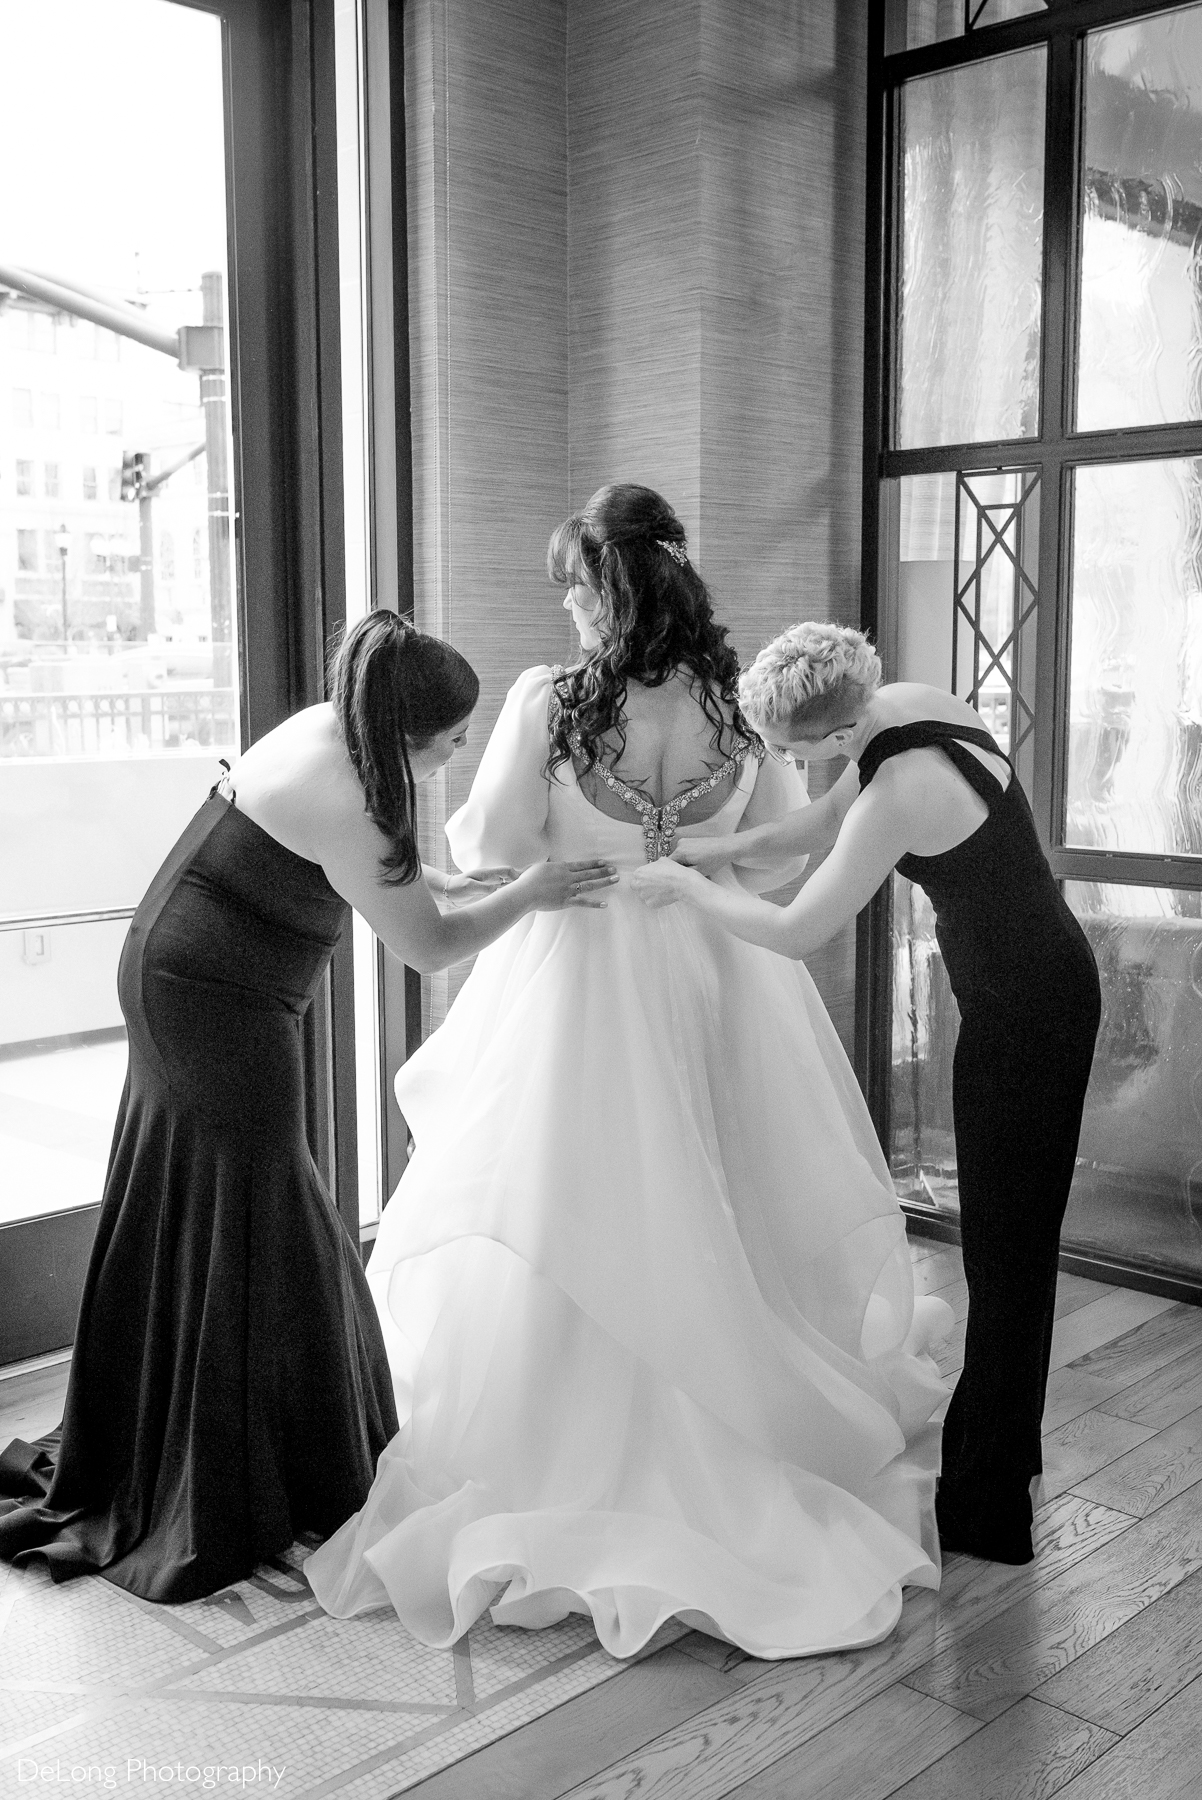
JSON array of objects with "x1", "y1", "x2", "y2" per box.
[{"x1": 862, "y1": 0, "x2": 1202, "y2": 1287}]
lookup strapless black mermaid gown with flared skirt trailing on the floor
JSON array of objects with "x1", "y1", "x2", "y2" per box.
[{"x1": 0, "y1": 790, "x2": 398, "y2": 1600}]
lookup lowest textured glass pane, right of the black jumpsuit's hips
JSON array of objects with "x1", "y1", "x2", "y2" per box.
[{"x1": 1063, "y1": 882, "x2": 1202, "y2": 1274}]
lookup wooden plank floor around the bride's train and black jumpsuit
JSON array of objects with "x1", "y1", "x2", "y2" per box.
[{"x1": 0, "y1": 1240, "x2": 1202, "y2": 1800}]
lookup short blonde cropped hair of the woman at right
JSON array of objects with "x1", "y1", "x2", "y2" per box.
[{"x1": 740, "y1": 621, "x2": 882, "y2": 738}]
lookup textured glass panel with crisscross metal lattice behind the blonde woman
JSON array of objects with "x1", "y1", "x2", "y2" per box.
[{"x1": 898, "y1": 470, "x2": 1040, "y2": 792}]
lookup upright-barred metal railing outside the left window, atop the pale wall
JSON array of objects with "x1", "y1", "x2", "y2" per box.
[{"x1": 0, "y1": 688, "x2": 238, "y2": 758}]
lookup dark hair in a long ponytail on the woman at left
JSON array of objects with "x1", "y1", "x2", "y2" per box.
[{"x1": 329, "y1": 607, "x2": 480, "y2": 886}]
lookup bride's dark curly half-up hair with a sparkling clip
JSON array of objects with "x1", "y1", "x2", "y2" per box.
[{"x1": 547, "y1": 482, "x2": 754, "y2": 774}]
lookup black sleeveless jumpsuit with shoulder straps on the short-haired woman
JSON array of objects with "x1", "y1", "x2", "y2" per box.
[{"x1": 860, "y1": 720, "x2": 1101, "y2": 1562}]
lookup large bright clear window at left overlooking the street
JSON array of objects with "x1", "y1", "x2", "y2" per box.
[{"x1": 0, "y1": 0, "x2": 239, "y2": 1224}]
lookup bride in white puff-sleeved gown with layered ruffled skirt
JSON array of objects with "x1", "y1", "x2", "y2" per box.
[{"x1": 306, "y1": 486, "x2": 950, "y2": 1658}]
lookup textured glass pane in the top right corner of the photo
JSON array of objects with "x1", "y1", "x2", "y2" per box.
[{"x1": 1076, "y1": 5, "x2": 1202, "y2": 430}]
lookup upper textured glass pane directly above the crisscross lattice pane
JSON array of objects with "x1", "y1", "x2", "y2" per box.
[{"x1": 898, "y1": 45, "x2": 1047, "y2": 448}]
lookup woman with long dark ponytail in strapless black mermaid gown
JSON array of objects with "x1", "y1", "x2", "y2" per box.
[{"x1": 0, "y1": 612, "x2": 610, "y2": 1600}]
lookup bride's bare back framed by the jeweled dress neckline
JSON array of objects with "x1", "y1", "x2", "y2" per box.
[{"x1": 576, "y1": 670, "x2": 736, "y2": 821}]
